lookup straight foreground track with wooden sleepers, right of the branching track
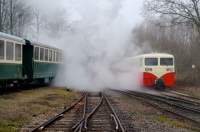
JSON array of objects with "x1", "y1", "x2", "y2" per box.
[{"x1": 84, "y1": 93, "x2": 125, "y2": 132}]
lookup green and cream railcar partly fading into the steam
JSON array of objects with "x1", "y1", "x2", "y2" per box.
[{"x1": 23, "y1": 40, "x2": 63, "y2": 83}]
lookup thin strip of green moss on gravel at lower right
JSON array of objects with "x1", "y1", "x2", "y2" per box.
[{"x1": 155, "y1": 116, "x2": 197, "y2": 131}]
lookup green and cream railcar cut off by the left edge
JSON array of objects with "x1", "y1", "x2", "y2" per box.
[{"x1": 0, "y1": 32, "x2": 25, "y2": 87}]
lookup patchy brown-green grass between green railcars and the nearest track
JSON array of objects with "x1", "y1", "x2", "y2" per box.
[{"x1": 0, "y1": 87, "x2": 80, "y2": 132}]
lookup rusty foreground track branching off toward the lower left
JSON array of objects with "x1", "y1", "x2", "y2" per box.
[{"x1": 22, "y1": 93, "x2": 87, "y2": 132}]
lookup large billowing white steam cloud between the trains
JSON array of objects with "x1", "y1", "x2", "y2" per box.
[{"x1": 28, "y1": 0, "x2": 145, "y2": 90}]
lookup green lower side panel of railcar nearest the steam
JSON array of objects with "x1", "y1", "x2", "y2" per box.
[{"x1": 33, "y1": 61, "x2": 60, "y2": 78}]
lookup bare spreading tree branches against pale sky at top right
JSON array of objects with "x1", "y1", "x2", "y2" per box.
[{"x1": 143, "y1": 0, "x2": 200, "y2": 33}]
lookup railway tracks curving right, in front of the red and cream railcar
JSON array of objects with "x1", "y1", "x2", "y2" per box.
[{"x1": 114, "y1": 90, "x2": 200, "y2": 130}]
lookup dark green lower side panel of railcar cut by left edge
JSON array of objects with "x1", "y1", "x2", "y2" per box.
[{"x1": 0, "y1": 63, "x2": 22, "y2": 82}]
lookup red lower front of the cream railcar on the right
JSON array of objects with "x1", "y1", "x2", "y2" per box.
[{"x1": 140, "y1": 72, "x2": 174, "y2": 87}]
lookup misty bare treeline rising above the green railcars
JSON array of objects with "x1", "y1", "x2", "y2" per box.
[{"x1": 0, "y1": 0, "x2": 72, "y2": 40}]
